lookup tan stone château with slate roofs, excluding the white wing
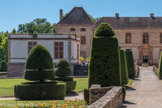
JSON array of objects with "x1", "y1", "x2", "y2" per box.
[{"x1": 56, "y1": 7, "x2": 162, "y2": 65}]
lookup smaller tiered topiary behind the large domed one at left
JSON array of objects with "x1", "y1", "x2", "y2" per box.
[{"x1": 55, "y1": 59, "x2": 76, "y2": 92}]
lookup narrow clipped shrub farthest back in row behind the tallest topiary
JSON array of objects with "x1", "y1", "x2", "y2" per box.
[{"x1": 126, "y1": 49, "x2": 136, "y2": 79}]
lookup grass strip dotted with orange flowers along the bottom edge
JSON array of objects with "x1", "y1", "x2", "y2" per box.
[{"x1": 0, "y1": 100, "x2": 87, "y2": 108}]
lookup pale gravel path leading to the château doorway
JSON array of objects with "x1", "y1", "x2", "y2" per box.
[{"x1": 122, "y1": 67, "x2": 162, "y2": 108}]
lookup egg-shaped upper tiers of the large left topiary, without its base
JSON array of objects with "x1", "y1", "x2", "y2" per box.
[{"x1": 24, "y1": 44, "x2": 54, "y2": 81}]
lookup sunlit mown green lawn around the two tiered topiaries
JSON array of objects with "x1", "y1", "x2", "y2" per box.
[{"x1": 0, "y1": 78, "x2": 88, "y2": 97}]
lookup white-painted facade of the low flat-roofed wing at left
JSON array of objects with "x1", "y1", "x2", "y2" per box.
[{"x1": 8, "y1": 34, "x2": 80, "y2": 77}]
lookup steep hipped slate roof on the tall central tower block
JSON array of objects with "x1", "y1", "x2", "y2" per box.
[{"x1": 58, "y1": 7, "x2": 94, "y2": 25}]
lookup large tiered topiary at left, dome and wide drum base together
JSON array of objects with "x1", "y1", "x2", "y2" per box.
[{"x1": 14, "y1": 45, "x2": 66, "y2": 100}]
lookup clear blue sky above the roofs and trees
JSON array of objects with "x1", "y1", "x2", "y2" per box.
[{"x1": 0, "y1": 0, "x2": 162, "y2": 32}]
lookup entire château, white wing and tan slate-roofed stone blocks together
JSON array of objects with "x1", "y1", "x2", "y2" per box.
[{"x1": 8, "y1": 7, "x2": 162, "y2": 77}]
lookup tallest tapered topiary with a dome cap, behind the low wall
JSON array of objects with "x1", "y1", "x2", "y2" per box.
[{"x1": 89, "y1": 23, "x2": 121, "y2": 87}]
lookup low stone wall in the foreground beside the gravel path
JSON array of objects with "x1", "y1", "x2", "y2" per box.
[{"x1": 88, "y1": 87, "x2": 123, "y2": 108}]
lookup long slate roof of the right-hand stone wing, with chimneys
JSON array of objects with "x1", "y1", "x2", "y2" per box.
[{"x1": 96, "y1": 17, "x2": 162, "y2": 29}]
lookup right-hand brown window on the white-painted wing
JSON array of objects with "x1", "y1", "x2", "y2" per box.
[{"x1": 54, "y1": 42, "x2": 64, "y2": 59}]
